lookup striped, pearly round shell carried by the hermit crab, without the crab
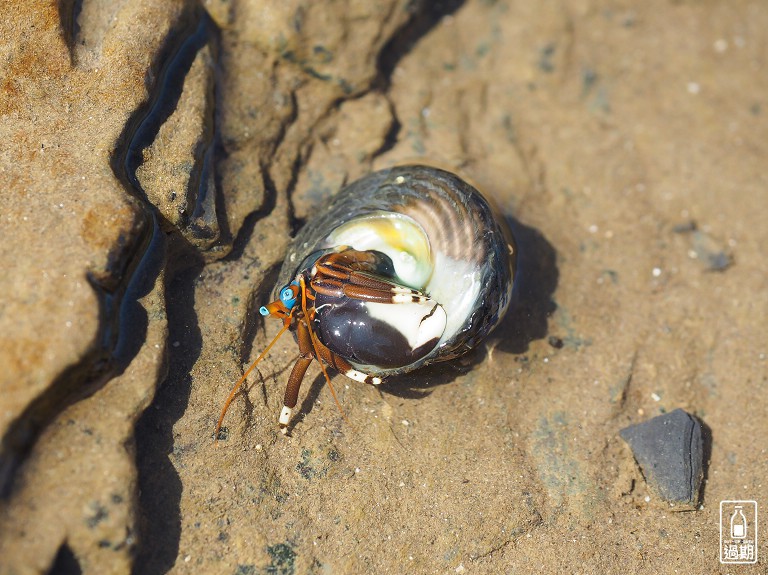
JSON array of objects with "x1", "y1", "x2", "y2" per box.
[{"x1": 276, "y1": 165, "x2": 517, "y2": 376}]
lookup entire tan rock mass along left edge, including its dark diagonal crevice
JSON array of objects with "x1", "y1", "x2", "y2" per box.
[{"x1": 0, "y1": 2, "x2": 181, "y2": 573}]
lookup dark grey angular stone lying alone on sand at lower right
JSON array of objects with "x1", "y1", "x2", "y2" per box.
[{"x1": 619, "y1": 409, "x2": 704, "y2": 511}]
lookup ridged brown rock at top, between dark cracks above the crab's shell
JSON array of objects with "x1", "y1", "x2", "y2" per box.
[{"x1": 211, "y1": 0, "x2": 411, "y2": 243}]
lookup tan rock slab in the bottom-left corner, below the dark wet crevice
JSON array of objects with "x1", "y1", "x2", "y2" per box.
[{"x1": 0, "y1": 278, "x2": 167, "y2": 574}]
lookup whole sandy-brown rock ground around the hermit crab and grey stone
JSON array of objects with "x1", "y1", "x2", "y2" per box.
[{"x1": 0, "y1": 0, "x2": 768, "y2": 575}]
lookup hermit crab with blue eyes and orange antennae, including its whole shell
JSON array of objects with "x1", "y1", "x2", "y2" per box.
[{"x1": 216, "y1": 165, "x2": 517, "y2": 436}]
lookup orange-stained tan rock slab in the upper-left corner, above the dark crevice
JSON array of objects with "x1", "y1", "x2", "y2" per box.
[{"x1": 0, "y1": 2, "x2": 179, "y2": 450}]
